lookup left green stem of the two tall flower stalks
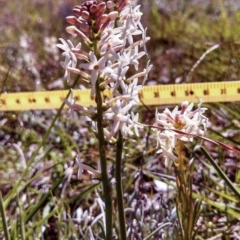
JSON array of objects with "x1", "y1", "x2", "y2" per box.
[{"x1": 96, "y1": 79, "x2": 112, "y2": 240}]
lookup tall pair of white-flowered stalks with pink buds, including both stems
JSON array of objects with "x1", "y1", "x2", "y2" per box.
[{"x1": 58, "y1": 0, "x2": 152, "y2": 239}]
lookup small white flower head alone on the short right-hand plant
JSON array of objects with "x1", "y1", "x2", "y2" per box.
[{"x1": 154, "y1": 101, "x2": 208, "y2": 163}]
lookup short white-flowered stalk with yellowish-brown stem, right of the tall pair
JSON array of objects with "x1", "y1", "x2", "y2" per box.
[{"x1": 154, "y1": 101, "x2": 208, "y2": 240}]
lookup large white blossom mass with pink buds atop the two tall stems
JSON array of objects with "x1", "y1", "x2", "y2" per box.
[{"x1": 58, "y1": 0, "x2": 152, "y2": 141}]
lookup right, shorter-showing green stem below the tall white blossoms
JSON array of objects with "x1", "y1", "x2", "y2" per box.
[{"x1": 116, "y1": 131, "x2": 127, "y2": 240}]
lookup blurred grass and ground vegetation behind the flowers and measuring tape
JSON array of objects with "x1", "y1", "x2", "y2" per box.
[{"x1": 0, "y1": 0, "x2": 240, "y2": 239}]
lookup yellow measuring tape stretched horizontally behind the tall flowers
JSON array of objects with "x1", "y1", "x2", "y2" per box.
[{"x1": 0, "y1": 81, "x2": 240, "y2": 111}]
